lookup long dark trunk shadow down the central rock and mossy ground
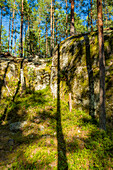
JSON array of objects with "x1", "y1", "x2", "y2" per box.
[{"x1": 56, "y1": 45, "x2": 68, "y2": 170}]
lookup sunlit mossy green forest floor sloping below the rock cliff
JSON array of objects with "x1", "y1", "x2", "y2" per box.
[{"x1": 0, "y1": 88, "x2": 113, "y2": 170}]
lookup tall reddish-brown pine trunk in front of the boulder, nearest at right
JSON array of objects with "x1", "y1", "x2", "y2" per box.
[{"x1": 97, "y1": 0, "x2": 106, "y2": 130}]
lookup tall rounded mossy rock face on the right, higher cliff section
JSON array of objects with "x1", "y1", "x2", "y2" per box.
[{"x1": 50, "y1": 30, "x2": 113, "y2": 117}]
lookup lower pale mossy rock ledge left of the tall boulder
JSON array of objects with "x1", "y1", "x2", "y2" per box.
[{"x1": 0, "y1": 54, "x2": 51, "y2": 98}]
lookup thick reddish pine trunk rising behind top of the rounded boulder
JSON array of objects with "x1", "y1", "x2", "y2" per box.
[{"x1": 70, "y1": 0, "x2": 75, "y2": 36}]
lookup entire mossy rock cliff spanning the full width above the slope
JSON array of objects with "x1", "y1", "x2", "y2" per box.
[{"x1": 0, "y1": 30, "x2": 113, "y2": 119}]
